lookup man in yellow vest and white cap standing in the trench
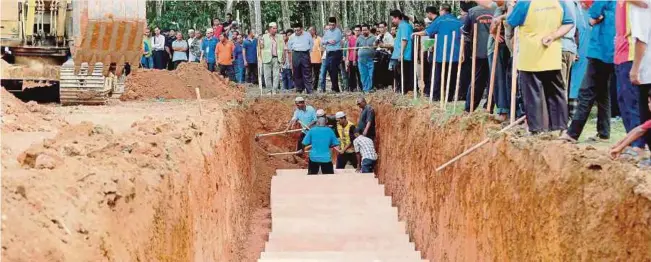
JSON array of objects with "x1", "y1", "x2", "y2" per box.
[{"x1": 335, "y1": 112, "x2": 357, "y2": 169}]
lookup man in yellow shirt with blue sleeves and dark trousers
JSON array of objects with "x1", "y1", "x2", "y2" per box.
[{"x1": 506, "y1": 0, "x2": 574, "y2": 134}]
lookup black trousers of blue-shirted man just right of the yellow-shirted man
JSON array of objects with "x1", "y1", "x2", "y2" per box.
[{"x1": 567, "y1": 58, "x2": 615, "y2": 139}]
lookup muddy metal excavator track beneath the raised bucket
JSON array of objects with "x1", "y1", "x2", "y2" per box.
[{"x1": 59, "y1": 61, "x2": 125, "y2": 105}]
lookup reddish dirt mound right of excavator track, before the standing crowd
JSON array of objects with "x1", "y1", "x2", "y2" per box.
[{"x1": 120, "y1": 63, "x2": 245, "y2": 102}]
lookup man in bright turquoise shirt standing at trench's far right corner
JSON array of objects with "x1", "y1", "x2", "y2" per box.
[{"x1": 389, "y1": 10, "x2": 414, "y2": 93}]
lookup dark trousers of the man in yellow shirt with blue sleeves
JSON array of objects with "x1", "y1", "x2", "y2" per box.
[{"x1": 519, "y1": 70, "x2": 568, "y2": 133}]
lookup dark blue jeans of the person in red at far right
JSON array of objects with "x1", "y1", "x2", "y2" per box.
[{"x1": 611, "y1": 61, "x2": 644, "y2": 148}]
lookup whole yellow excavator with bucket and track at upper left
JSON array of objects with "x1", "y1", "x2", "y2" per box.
[{"x1": 0, "y1": 0, "x2": 146, "y2": 105}]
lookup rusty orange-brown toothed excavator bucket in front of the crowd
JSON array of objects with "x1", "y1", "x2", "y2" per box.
[{"x1": 73, "y1": 0, "x2": 146, "y2": 76}]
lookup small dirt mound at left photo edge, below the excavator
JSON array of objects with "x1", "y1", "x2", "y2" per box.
[{"x1": 0, "y1": 87, "x2": 67, "y2": 132}]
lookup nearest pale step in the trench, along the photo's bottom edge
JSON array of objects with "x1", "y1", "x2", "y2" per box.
[{"x1": 260, "y1": 251, "x2": 421, "y2": 262}]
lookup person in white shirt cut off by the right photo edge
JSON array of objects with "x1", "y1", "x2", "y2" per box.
[{"x1": 629, "y1": 0, "x2": 651, "y2": 158}]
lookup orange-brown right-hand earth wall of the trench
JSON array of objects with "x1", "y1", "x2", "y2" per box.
[{"x1": 376, "y1": 104, "x2": 651, "y2": 261}]
